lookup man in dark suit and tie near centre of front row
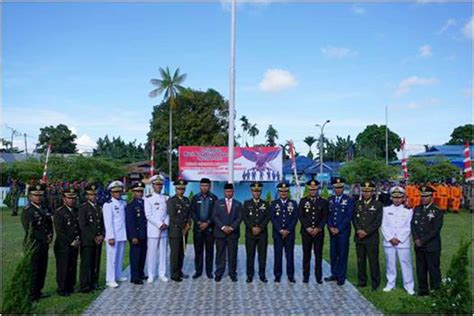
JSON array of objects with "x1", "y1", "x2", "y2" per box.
[{"x1": 212, "y1": 183, "x2": 242, "y2": 282}]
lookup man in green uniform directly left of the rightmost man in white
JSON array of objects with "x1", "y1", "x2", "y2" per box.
[{"x1": 352, "y1": 181, "x2": 383, "y2": 291}]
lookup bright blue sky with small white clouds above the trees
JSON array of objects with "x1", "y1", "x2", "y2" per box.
[{"x1": 2, "y1": 0, "x2": 473, "y2": 157}]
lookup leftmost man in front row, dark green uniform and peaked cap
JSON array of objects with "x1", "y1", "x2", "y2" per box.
[{"x1": 21, "y1": 183, "x2": 53, "y2": 301}]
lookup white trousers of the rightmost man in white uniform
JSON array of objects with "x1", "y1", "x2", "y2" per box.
[{"x1": 384, "y1": 247, "x2": 415, "y2": 293}]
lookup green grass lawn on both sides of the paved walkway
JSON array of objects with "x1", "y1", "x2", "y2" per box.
[{"x1": 0, "y1": 208, "x2": 472, "y2": 314}]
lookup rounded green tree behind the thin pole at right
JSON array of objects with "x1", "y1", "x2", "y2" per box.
[{"x1": 356, "y1": 124, "x2": 401, "y2": 160}]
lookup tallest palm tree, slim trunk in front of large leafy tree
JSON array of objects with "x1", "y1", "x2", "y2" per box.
[{"x1": 148, "y1": 67, "x2": 186, "y2": 182}]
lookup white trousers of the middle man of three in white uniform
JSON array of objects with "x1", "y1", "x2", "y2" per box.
[{"x1": 146, "y1": 237, "x2": 168, "y2": 280}]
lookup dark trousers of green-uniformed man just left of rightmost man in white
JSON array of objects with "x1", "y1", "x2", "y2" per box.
[{"x1": 356, "y1": 242, "x2": 380, "y2": 289}]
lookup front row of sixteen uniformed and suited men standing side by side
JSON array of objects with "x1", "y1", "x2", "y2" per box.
[{"x1": 22, "y1": 175, "x2": 443, "y2": 300}]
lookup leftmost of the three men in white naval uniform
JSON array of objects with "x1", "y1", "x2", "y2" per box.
[{"x1": 102, "y1": 181, "x2": 127, "y2": 288}]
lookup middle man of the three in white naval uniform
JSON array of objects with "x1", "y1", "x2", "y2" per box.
[{"x1": 145, "y1": 175, "x2": 170, "y2": 283}]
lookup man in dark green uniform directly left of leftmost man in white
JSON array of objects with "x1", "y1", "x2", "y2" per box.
[{"x1": 79, "y1": 184, "x2": 105, "y2": 293}]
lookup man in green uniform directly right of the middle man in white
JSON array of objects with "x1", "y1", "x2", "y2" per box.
[{"x1": 167, "y1": 180, "x2": 191, "y2": 282}]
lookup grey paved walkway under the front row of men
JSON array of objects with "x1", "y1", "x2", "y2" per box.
[{"x1": 85, "y1": 246, "x2": 379, "y2": 315}]
